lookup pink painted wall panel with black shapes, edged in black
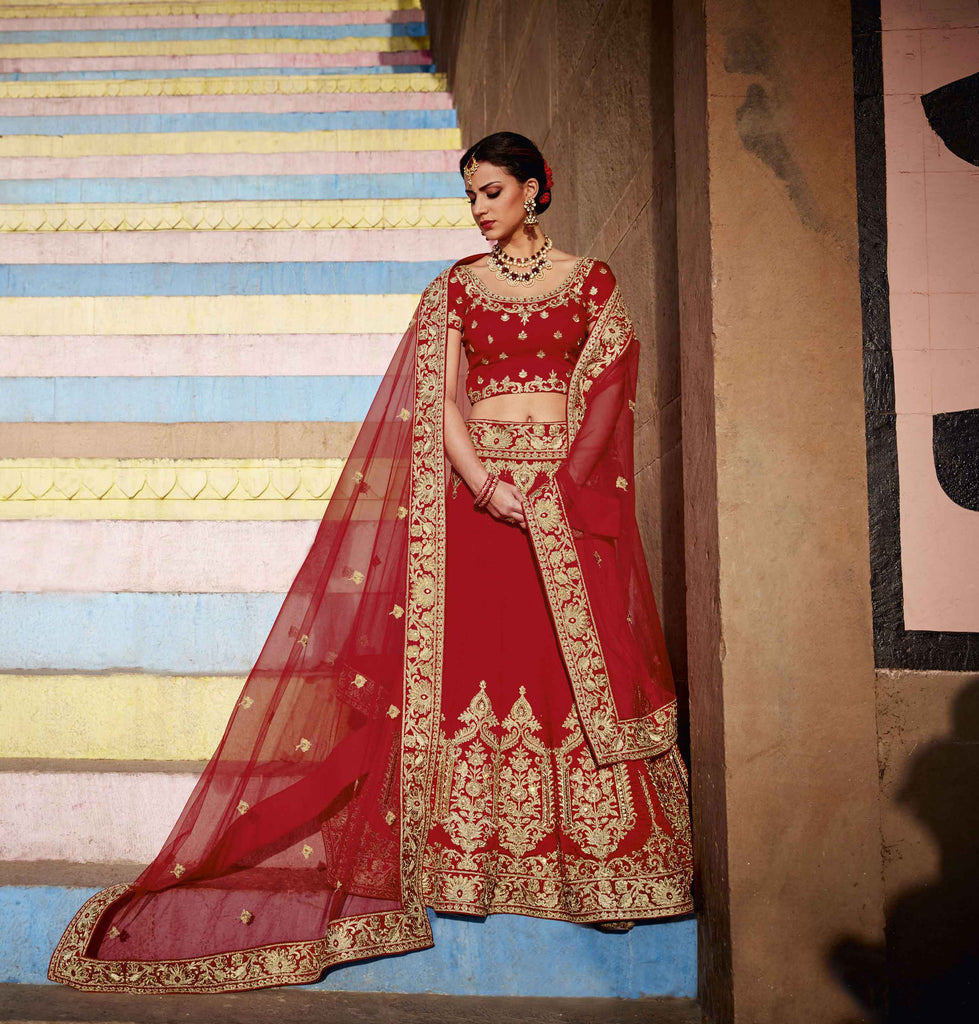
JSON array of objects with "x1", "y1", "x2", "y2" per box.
[{"x1": 882, "y1": 0, "x2": 979, "y2": 632}]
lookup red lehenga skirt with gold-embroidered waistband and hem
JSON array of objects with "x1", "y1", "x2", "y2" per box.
[{"x1": 424, "y1": 419, "x2": 692, "y2": 922}]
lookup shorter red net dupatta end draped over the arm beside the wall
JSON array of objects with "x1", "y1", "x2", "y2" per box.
[{"x1": 525, "y1": 286, "x2": 676, "y2": 764}]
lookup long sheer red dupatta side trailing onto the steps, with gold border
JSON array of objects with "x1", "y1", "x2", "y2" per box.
[{"x1": 49, "y1": 272, "x2": 448, "y2": 992}]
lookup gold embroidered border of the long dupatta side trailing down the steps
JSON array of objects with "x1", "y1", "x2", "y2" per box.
[{"x1": 48, "y1": 270, "x2": 449, "y2": 993}]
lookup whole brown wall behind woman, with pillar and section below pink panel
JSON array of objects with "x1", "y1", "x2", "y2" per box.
[{"x1": 425, "y1": 0, "x2": 979, "y2": 1024}]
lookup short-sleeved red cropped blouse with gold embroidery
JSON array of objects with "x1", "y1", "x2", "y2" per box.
[{"x1": 449, "y1": 257, "x2": 615, "y2": 404}]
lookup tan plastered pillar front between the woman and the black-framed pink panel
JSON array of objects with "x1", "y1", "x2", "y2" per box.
[{"x1": 674, "y1": 0, "x2": 883, "y2": 1024}]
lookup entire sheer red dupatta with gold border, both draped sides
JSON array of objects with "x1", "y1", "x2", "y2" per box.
[{"x1": 48, "y1": 257, "x2": 674, "y2": 992}]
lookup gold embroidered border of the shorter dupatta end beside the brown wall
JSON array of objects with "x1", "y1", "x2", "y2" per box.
[{"x1": 524, "y1": 285, "x2": 677, "y2": 764}]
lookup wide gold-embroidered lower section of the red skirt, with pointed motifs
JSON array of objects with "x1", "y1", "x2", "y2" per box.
[{"x1": 424, "y1": 681, "x2": 691, "y2": 921}]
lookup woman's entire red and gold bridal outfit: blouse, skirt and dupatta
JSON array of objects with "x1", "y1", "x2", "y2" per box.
[{"x1": 49, "y1": 257, "x2": 691, "y2": 992}]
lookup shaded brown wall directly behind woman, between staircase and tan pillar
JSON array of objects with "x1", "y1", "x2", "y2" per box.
[{"x1": 424, "y1": 0, "x2": 686, "y2": 686}]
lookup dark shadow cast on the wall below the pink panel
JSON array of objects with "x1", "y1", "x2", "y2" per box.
[{"x1": 829, "y1": 678, "x2": 979, "y2": 1024}]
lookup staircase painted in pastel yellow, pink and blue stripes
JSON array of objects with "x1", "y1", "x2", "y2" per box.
[{"x1": 0, "y1": 0, "x2": 695, "y2": 996}]
